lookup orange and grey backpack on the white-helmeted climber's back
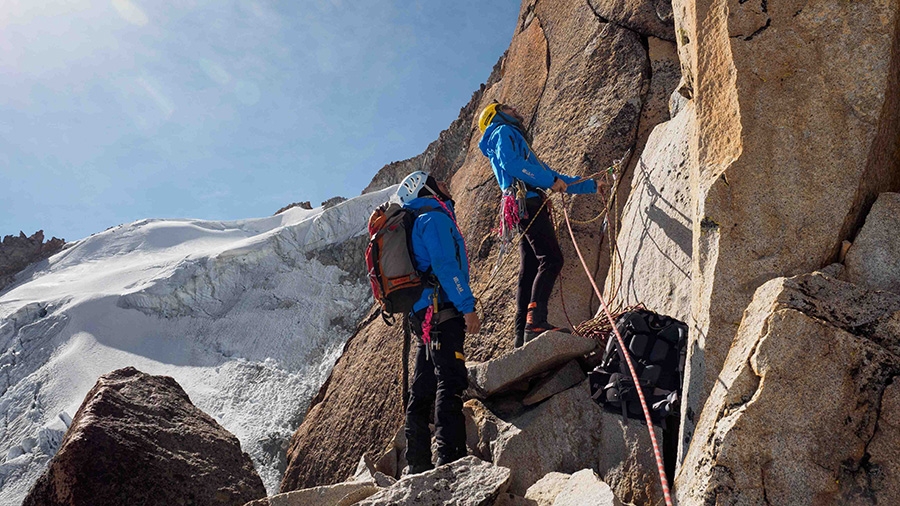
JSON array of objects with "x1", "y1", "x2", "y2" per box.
[{"x1": 366, "y1": 202, "x2": 429, "y2": 325}]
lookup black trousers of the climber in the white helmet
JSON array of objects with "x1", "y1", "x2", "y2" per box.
[{"x1": 406, "y1": 315, "x2": 469, "y2": 467}]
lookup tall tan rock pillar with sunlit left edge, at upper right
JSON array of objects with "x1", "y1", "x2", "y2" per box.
[{"x1": 672, "y1": 0, "x2": 900, "y2": 462}]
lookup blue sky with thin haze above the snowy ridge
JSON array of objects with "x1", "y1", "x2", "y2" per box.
[{"x1": 0, "y1": 0, "x2": 520, "y2": 241}]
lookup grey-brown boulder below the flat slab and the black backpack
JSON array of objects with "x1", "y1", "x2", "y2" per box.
[{"x1": 463, "y1": 381, "x2": 662, "y2": 504}]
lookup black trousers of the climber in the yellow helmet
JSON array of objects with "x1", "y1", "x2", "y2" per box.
[{"x1": 515, "y1": 197, "x2": 563, "y2": 347}]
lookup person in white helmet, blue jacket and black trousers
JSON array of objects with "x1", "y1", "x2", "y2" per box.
[{"x1": 397, "y1": 171, "x2": 481, "y2": 474}]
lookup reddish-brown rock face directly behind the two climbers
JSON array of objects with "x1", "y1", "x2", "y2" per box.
[{"x1": 282, "y1": 0, "x2": 679, "y2": 492}]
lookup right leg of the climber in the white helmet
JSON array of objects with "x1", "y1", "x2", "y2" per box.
[{"x1": 433, "y1": 317, "x2": 469, "y2": 465}]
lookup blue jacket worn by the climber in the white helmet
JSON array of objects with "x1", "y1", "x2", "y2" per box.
[{"x1": 403, "y1": 197, "x2": 475, "y2": 314}]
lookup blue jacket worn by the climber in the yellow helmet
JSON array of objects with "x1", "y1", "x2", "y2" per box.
[{"x1": 478, "y1": 119, "x2": 597, "y2": 197}]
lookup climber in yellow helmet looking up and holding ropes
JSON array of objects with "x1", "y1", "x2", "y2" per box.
[{"x1": 478, "y1": 101, "x2": 597, "y2": 347}]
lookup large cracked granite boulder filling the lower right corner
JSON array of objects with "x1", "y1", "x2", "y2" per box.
[{"x1": 675, "y1": 273, "x2": 900, "y2": 505}]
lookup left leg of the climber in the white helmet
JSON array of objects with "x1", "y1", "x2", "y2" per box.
[{"x1": 406, "y1": 343, "x2": 437, "y2": 474}]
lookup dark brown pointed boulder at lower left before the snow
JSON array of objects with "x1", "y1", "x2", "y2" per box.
[{"x1": 23, "y1": 368, "x2": 266, "y2": 506}]
